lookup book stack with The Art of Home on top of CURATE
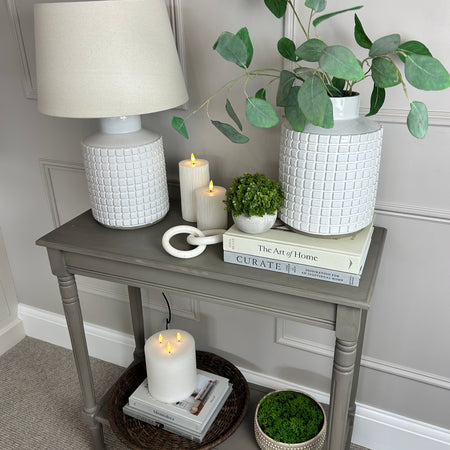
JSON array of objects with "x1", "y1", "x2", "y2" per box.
[{"x1": 223, "y1": 223, "x2": 373, "y2": 286}]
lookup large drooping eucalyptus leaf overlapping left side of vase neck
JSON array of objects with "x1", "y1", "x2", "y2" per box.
[{"x1": 297, "y1": 76, "x2": 331, "y2": 127}]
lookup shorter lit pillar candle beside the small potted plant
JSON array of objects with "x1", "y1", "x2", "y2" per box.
[{"x1": 195, "y1": 181, "x2": 228, "y2": 230}]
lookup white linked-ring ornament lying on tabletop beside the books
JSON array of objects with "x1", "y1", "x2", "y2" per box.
[{"x1": 162, "y1": 225, "x2": 226, "y2": 259}]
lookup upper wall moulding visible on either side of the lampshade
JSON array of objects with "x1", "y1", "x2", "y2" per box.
[{"x1": 6, "y1": 0, "x2": 186, "y2": 101}]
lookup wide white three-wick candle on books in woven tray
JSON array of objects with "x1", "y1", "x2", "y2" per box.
[{"x1": 145, "y1": 330, "x2": 197, "y2": 403}]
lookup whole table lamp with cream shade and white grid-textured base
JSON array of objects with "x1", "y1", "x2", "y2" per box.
[{"x1": 34, "y1": 0, "x2": 188, "y2": 229}]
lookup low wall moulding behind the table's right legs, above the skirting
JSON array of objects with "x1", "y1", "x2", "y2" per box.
[{"x1": 275, "y1": 319, "x2": 450, "y2": 390}]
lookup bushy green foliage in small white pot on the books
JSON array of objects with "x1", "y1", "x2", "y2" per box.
[{"x1": 225, "y1": 173, "x2": 283, "y2": 217}]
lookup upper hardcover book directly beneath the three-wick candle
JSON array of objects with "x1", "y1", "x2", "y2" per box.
[{"x1": 128, "y1": 369, "x2": 230, "y2": 433}]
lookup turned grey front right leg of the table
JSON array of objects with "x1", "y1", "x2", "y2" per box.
[{"x1": 327, "y1": 306, "x2": 362, "y2": 450}]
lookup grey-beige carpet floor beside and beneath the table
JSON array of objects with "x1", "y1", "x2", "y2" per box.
[{"x1": 0, "y1": 337, "x2": 370, "y2": 450}]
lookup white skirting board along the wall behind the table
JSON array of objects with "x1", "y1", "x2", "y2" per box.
[{"x1": 18, "y1": 304, "x2": 450, "y2": 450}]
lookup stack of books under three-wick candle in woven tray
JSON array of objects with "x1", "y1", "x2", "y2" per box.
[{"x1": 123, "y1": 369, "x2": 232, "y2": 442}]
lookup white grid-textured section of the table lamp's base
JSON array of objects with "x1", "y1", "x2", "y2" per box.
[{"x1": 82, "y1": 137, "x2": 169, "y2": 229}]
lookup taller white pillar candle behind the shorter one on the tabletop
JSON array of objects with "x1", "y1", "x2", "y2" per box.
[{"x1": 178, "y1": 154, "x2": 210, "y2": 222}]
